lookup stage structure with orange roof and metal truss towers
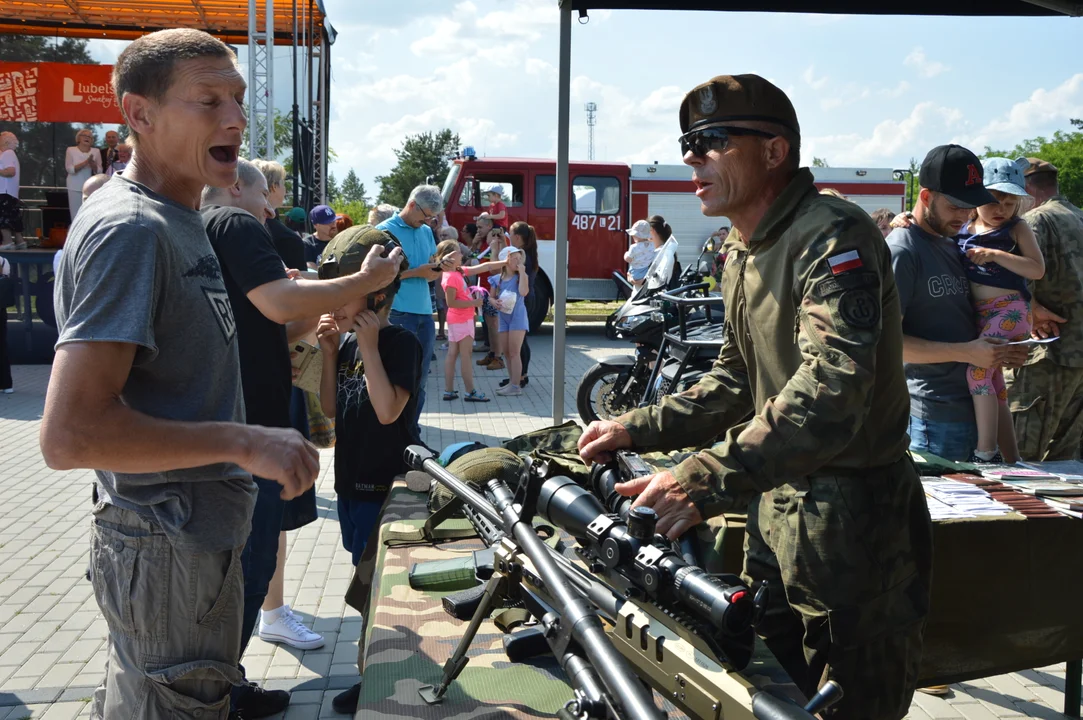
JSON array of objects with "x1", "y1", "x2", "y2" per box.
[{"x1": 0, "y1": 0, "x2": 336, "y2": 208}]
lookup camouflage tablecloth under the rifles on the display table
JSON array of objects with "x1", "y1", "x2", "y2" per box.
[{"x1": 347, "y1": 483, "x2": 800, "y2": 720}]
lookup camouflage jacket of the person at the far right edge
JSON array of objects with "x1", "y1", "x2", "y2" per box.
[{"x1": 1023, "y1": 195, "x2": 1083, "y2": 367}]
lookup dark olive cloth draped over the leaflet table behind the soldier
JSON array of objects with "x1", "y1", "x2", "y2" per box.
[{"x1": 718, "y1": 500, "x2": 1083, "y2": 718}]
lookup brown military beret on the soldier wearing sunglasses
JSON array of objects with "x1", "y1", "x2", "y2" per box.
[{"x1": 680, "y1": 75, "x2": 801, "y2": 135}]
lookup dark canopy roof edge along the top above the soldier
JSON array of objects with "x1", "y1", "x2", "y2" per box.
[{"x1": 561, "y1": 0, "x2": 1083, "y2": 16}]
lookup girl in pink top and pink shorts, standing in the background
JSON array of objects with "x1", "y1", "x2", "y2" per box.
[{"x1": 436, "y1": 240, "x2": 507, "y2": 403}]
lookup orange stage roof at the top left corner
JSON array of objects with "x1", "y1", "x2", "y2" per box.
[{"x1": 0, "y1": 0, "x2": 335, "y2": 44}]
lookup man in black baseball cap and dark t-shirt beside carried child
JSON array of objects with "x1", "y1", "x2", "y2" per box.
[{"x1": 887, "y1": 145, "x2": 1026, "y2": 460}]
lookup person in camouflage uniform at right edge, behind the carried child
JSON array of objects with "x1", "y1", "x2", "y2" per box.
[{"x1": 1006, "y1": 158, "x2": 1083, "y2": 460}]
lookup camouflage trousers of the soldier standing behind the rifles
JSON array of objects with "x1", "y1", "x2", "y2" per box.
[{"x1": 744, "y1": 458, "x2": 932, "y2": 720}]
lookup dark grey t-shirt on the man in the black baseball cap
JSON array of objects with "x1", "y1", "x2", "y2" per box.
[{"x1": 887, "y1": 224, "x2": 978, "y2": 422}]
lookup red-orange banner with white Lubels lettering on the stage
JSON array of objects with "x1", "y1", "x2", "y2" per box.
[{"x1": 0, "y1": 63, "x2": 123, "y2": 125}]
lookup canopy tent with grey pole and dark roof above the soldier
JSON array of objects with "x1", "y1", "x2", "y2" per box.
[{"x1": 552, "y1": 0, "x2": 1083, "y2": 424}]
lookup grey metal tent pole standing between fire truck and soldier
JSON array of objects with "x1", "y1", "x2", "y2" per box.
[{"x1": 552, "y1": 0, "x2": 572, "y2": 424}]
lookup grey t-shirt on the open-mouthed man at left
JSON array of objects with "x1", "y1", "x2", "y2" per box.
[{"x1": 54, "y1": 176, "x2": 256, "y2": 552}]
